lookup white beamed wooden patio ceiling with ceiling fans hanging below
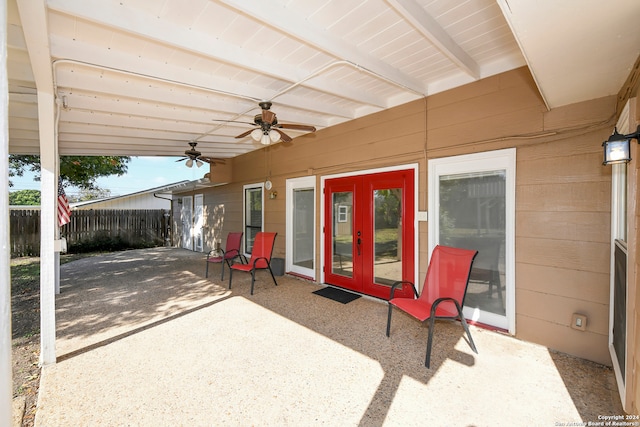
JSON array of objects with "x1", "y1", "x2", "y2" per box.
[{"x1": 7, "y1": 0, "x2": 640, "y2": 158}]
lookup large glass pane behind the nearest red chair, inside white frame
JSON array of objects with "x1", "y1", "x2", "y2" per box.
[{"x1": 439, "y1": 170, "x2": 506, "y2": 315}]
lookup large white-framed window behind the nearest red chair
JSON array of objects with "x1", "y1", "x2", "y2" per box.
[{"x1": 428, "y1": 148, "x2": 516, "y2": 334}]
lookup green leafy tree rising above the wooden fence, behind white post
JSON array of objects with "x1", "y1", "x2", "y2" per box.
[{"x1": 9, "y1": 154, "x2": 131, "y2": 190}]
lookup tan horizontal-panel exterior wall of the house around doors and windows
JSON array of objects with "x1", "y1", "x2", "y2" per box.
[{"x1": 174, "y1": 68, "x2": 616, "y2": 365}]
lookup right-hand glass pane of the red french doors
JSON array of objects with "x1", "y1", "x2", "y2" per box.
[{"x1": 373, "y1": 188, "x2": 402, "y2": 286}]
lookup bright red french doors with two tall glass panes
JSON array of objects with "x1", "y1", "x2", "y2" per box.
[{"x1": 324, "y1": 170, "x2": 415, "y2": 299}]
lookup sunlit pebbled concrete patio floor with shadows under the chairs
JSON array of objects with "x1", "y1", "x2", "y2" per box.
[{"x1": 35, "y1": 248, "x2": 623, "y2": 426}]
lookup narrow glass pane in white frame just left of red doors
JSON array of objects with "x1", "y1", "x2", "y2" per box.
[{"x1": 293, "y1": 188, "x2": 314, "y2": 269}]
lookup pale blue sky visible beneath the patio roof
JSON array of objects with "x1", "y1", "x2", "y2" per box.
[{"x1": 9, "y1": 157, "x2": 208, "y2": 196}]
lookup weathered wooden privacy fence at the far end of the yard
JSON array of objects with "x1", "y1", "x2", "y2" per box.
[{"x1": 9, "y1": 209, "x2": 169, "y2": 257}]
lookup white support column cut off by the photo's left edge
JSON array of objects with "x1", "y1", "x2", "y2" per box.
[{"x1": 0, "y1": 0, "x2": 13, "y2": 426}]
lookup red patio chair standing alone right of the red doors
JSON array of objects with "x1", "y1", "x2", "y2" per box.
[{"x1": 387, "y1": 245, "x2": 478, "y2": 368}]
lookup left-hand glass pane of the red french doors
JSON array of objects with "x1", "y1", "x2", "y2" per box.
[{"x1": 331, "y1": 191, "x2": 353, "y2": 277}]
